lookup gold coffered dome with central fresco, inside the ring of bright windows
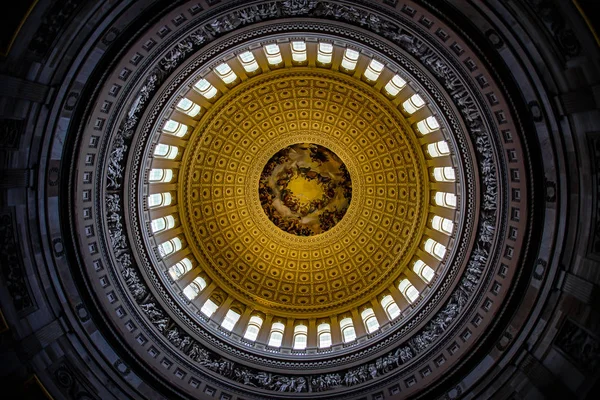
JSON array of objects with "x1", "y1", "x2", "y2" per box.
[{"x1": 179, "y1": 71, "x2": 429, "y2": 316}]
